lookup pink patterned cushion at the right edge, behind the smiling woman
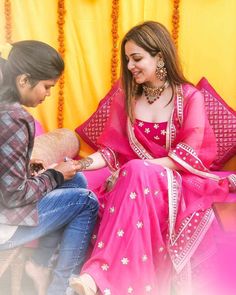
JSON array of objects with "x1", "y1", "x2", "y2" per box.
[{"x1": 196, "y1": 77, "x2": 236, "y2": 170}]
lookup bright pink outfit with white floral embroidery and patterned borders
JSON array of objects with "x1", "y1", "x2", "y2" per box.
[{"x1": 82, "y1": 85, "x2": 228, "y2": 295}]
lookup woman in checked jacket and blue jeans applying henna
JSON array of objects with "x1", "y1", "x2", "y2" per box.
[{"x1": 0, "y1": 40, "x2": 98, "y2": 295}]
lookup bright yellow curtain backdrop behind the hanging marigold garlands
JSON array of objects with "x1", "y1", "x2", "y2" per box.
[{"x1": 0, "y1": 0, "x2": 236, "y2": 155}]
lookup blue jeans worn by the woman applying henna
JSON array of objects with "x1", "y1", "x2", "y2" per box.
[{"x1": 0, "y1": 173, "x2": 98, "y2": 295}]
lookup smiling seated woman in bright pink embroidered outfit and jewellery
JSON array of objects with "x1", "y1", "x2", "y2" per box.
[{"x1": 70, "y1": 21, "x2": 234, "y2": 295}]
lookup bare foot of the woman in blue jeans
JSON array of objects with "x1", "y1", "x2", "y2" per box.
[{"x1": 25, "y1": 260, "x2": 51, "y2": 295}]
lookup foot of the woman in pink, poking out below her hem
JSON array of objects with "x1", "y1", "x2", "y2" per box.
[{"x1": 69, "y1": 273, "x2": 97, "y2": 295}]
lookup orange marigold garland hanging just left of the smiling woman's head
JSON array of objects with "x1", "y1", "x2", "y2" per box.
[{"x1": 111, "y1": 0, "x2": 119, "y2": 85}]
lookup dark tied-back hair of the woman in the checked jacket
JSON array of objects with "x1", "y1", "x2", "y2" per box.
[{"x1": 0, "y1": 40, "x2": 64, "y2": 102}]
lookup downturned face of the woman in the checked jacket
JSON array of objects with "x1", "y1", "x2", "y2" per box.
[{"x1": 17, "y1": 79, "x2": 58, "y2": 107}]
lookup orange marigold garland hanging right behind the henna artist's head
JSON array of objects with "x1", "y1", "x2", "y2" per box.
[{"x1": 57, "y1": 0, "x2": 66, "y2": 128}]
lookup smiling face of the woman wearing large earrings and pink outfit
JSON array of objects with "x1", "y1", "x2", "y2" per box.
[{"x1": 125, "y1": 41, "x2": 160, "y2": 84}]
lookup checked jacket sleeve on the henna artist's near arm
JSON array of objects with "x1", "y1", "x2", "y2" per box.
[{"x1": 0, "y1": 108, "x2": 57, "y2": 208}]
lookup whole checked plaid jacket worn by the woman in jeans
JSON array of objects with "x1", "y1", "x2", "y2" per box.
[{"x1": 0, "y1": 103, "x2": 57, "y2": 226}]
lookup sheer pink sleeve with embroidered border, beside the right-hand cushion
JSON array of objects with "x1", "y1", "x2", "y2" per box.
[{"x1": 169, "y1": 85, "x2": 217, "y2": 178}]
